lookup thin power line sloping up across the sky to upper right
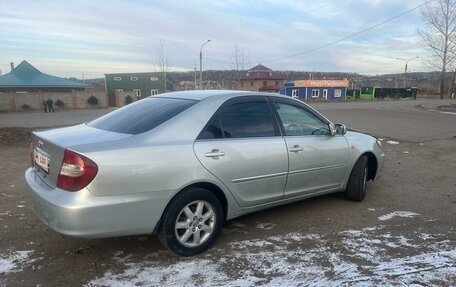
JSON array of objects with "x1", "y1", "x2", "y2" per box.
[{"x1": 208, "y1": 1, "x2": 431, "y2": 64}]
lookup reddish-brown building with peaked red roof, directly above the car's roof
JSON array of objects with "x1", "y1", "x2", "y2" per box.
[{"x1": 241, "y1": 64, "x2": 285, "y2": 93}]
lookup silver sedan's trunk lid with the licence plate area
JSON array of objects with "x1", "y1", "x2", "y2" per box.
[{"x1": 31, "y1": 124, "x2": 132, "y2": 188}]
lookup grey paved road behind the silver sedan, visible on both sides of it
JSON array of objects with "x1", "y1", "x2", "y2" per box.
[{"x1": 0, "y1": 100, "x2": 456, "y2": 142}]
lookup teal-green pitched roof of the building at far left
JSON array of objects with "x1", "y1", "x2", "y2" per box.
[{"x1": 0, "y1": 60, "x2": 88, "y2": 92}]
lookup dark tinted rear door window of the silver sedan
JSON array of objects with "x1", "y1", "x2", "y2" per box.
[{"x1": 198, "y1": 100, "x2": 276, "y2": 139}]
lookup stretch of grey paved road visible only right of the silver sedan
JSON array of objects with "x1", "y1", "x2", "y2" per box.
[{"x1": 312, "y1": 100, "x2": 456, "y2": 142}]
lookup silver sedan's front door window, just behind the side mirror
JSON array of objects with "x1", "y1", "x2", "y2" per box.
[{"x1": 273, "y1": 102, "x2": 330, "y2": 136}]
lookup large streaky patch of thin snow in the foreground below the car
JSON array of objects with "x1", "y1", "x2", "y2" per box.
[{"x1": 87, "y1": 225, "x2": 456, "y2": 287}]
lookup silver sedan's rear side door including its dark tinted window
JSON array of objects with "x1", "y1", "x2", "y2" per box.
[{"x1": 194, "y1": 96, "x2": 288, "y2": 206}]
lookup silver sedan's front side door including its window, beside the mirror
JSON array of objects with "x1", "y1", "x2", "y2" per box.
[{"x1": 272, "y1": 99, "x2": 349, "y2": 198}]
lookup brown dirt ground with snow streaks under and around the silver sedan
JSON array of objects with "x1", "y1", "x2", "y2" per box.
[{"x1": 0, "y1": 107, "x2": 456, "y2": 286}]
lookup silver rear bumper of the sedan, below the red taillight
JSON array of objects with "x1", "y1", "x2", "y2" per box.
[{"x1": 25, "y1": 168, "x2": 173, "y2": 238}]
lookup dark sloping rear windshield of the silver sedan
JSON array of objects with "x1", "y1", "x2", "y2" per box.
[{"x1": 87, "y1": 97, "x2": 197, "y2": 135}]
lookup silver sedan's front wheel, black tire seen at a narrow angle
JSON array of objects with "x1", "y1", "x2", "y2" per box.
[{"x1": 345, "y1": 155, "x2": 369, "y2": 201}]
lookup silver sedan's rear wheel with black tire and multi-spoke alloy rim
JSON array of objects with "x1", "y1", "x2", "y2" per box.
[{"x1": 158, "y1": 188, "x2": 224, "y2": 256}]
